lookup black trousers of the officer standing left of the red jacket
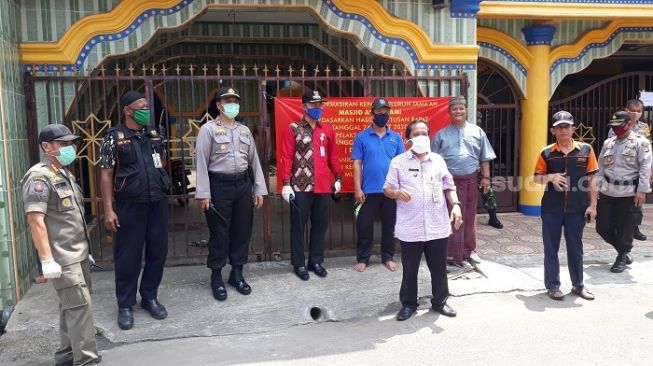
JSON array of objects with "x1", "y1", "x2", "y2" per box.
[{"x1": 206, "y1": 176, "x2": 254, "y2": 270}]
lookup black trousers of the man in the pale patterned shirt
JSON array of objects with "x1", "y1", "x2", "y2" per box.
[{"x1": 399, "y1": 238, "x2": 449, "y2": 309}]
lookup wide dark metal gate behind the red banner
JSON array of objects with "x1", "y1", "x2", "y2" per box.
[{"x1": 25, "y1": 64, "x2": 467, "y2": 265}]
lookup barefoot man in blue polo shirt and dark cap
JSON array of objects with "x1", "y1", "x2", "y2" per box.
[{"x1": 351, "y1": 98, "x2": 405, "y2": 272}]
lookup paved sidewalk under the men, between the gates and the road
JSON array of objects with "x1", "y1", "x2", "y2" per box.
[{"x1": 0, "y1": 207, "x2": 653, "y2": 365}]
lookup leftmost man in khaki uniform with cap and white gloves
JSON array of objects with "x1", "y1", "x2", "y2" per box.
[{"x1": 22, "y1": 124, "x2": 101, "y2": 365}]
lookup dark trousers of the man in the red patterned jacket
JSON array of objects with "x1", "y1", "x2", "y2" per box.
[{"x1": 290, "y1": 192, "x2": 331, "y2": 266}]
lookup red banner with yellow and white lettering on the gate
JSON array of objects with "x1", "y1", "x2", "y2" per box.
[{"x1": 274, "y1": 97, "x2": 451, "y2": 193}]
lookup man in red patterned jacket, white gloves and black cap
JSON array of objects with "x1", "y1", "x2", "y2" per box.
[{"x1": 281, "y1": 91, "x2": 342, "y2": 281}]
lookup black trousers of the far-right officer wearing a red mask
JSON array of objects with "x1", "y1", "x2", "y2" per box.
[{"x1": 596, "y1": 193, "x2": 641, "y2": 254}]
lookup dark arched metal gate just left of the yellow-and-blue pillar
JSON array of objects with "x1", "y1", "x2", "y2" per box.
[{"x1": 476, "y1": 61, "x2": 520, "y2": 212}]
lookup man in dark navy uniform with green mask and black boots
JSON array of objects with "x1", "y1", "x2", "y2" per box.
[{"x1": 100, "y1": 91, "x2": 169, "y2": 330}]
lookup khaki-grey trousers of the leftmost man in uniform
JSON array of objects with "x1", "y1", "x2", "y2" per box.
[{"x1": 50, "y1": 260, "x2": 100, "y2": 365}]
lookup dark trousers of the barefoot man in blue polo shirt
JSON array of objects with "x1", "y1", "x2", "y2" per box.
[{"x1": 356, "y1": 193, "x2": 397, "y2": 264}]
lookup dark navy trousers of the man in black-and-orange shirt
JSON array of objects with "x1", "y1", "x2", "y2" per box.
[{"x1": 542, "y1": 212, "x2": 585, "y2": 290}]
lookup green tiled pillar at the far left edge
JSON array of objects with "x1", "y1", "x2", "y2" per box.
[{"x1": 0, "y1": 0, "x2": 38, "y2": 308}]
